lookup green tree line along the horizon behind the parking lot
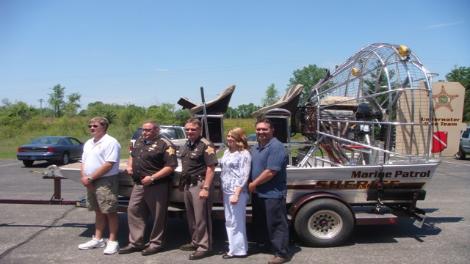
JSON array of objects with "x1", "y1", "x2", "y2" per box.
[{"x1": 0, "y1": 65, "x2": 470, "y2": 132}]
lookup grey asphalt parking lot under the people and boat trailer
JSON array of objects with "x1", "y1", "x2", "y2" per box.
[{"x1": 0, "y1": 158, "x2": 470, "y2": 264}]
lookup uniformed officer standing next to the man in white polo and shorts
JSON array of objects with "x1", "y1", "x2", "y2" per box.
[{"x1": 119, "y1": 121, "x2": 178, "y2": 256}]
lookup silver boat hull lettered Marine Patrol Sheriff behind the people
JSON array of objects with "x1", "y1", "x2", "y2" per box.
[{"x1": 60, "y1": 161, "x2": 439, "y2": 204}]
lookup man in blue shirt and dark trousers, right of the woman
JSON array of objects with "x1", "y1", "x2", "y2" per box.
[{"x1": 248, "y1": 119, "x2": 290, "y2": 264}]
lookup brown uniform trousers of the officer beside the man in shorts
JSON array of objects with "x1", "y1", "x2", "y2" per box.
[{"x1": 127, "y1": 181, "x2": 169, "y2": 248}]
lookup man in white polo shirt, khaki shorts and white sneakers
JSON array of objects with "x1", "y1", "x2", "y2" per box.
[{"x1": 78, "y1": 117, "x2": 121, "y2": 255}]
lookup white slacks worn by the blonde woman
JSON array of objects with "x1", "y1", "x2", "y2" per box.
[{"x1": 224, "y1": 192, "x2": 248, "y2": 256}]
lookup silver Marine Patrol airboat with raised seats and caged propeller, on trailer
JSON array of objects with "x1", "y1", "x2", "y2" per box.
[{"x1": 61, "y1": 43, "x2": 439, "y2": 246}]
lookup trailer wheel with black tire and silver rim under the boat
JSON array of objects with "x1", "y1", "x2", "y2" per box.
[{"x1": 294, "y1": 199, "x2": 354, "y2": 247}]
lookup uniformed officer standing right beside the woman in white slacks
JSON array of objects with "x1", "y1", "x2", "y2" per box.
[{"x1": 180, "y1": 118, "x2": 217, "y2": 260}]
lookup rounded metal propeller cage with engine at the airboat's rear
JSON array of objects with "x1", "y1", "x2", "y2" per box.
[{"x1": 295, "y1": 43, "x2": 434, "y2": 166}]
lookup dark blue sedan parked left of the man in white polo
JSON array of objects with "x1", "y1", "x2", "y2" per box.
[{"x1": 16, "y1": 136, "x2": 83, "y2": 167}]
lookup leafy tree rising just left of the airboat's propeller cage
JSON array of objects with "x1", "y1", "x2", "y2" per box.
[{"x1": 289, "y1": 64, "x2": 328, "y2": 103}]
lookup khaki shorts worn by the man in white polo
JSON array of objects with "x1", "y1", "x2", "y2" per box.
[{"x1": 87, "y1": 175, "x2": 119, "y2": 214}]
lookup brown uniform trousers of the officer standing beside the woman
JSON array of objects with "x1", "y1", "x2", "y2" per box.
[{"x1": 184, "y1": 181, "x2": 214, "y2": 251}]
